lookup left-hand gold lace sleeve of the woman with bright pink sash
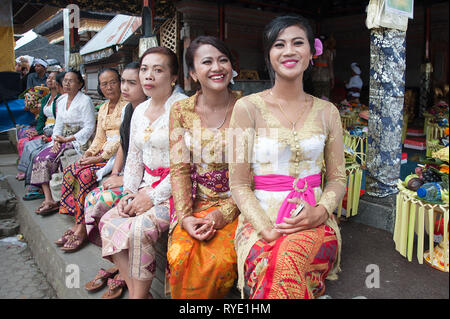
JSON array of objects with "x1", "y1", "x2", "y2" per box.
[{"x1": 229, "y1": 98, "x2": 273, "y2": 233}]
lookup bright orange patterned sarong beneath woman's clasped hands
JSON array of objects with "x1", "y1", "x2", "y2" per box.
[{"x1": 167, "y1": 207, "x2": 238, "y2": 299}]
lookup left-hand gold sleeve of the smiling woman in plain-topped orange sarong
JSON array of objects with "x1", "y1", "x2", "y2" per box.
[{"x1": 169, "y1": 102, "x2": 193, "y2": 226}]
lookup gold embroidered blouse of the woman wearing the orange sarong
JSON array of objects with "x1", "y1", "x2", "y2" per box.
[{"x1": 169, "y1": 92, "x2": 239, "y2": 229}]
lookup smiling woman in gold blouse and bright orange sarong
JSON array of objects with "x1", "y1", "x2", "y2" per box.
[{"x1": 167, "y1": 36, "x2": 238, "y2": 299}]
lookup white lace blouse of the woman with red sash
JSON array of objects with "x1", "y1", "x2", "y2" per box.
[{"x1": 124, "y1": 92, "x2": 187, "y2": 205}]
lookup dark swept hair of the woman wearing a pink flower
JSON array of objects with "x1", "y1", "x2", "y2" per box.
[{"x1": 263, "y1": 14, "x2": 316, "y2": 83}]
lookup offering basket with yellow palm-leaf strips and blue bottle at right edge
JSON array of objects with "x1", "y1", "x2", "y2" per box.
[{"x1": 394, "y1": 146, "x2": 449, "y2": 272}]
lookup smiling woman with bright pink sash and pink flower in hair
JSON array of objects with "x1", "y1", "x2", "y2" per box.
[{"x1": 230, "y1": 16, "x2": 346, "y2": 299}]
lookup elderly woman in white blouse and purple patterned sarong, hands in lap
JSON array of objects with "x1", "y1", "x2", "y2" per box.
[{"x1": 30, "y1": 71, "x2": 95, "y2": 214}]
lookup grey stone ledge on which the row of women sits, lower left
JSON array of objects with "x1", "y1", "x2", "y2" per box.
[{"x1": 0, "y1": 166, "x2": 240, "y2": 299}]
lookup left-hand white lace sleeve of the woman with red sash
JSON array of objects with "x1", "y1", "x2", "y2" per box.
[{"x1": 123, "y1": 110, "x2": 144, "y2": 193}]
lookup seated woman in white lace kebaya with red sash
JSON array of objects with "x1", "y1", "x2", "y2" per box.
[{"x1": 99, "y1": 47, "x2": 186, "y2": 299}]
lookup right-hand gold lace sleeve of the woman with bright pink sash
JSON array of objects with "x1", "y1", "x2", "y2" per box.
[{"x1": 318, "y1": 105, "x2": 347, "y2": 214}]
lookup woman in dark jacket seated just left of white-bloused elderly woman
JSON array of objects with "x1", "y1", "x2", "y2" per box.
[{"x1": 17, "y1": 72, "x2": 65, "y2": 200}]
